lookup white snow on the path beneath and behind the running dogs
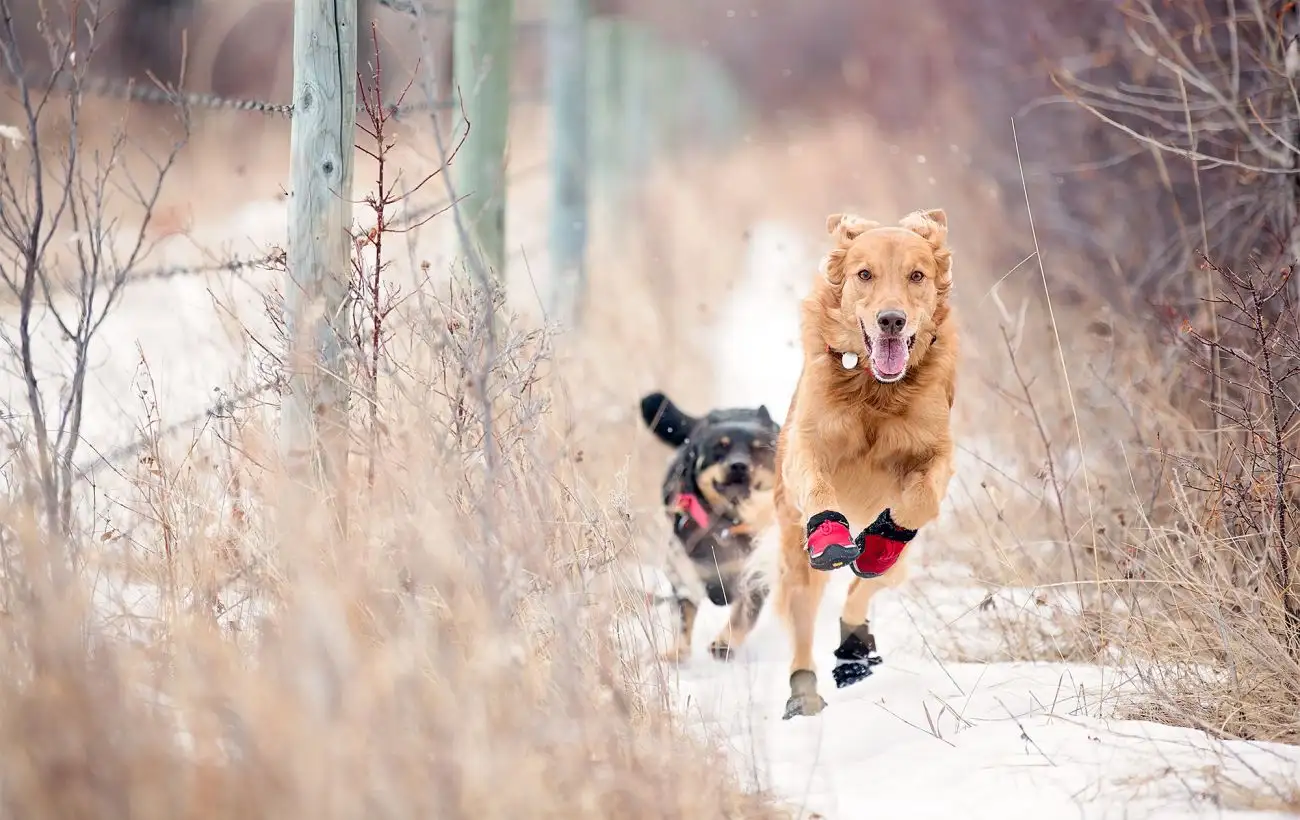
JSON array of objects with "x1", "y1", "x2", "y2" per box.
[{"x1": 675, "y1": 224, "x2": 1300, "y2": 820}]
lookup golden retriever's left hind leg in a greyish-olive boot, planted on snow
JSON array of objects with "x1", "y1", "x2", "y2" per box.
[{"x1": 777, "y1": 524, "x2": 829, "y2": 720}]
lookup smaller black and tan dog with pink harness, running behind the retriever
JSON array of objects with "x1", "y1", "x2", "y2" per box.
[{"x1": 641, "y1": 392, "x2": 780, "y2": 660}]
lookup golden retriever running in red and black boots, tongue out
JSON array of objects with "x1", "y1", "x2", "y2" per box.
[{"x1": 775, "y1": 209, "x2": 958, "y2": 719}]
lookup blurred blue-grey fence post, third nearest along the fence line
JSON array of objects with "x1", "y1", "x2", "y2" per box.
[{"x1": 547, "y1": 0, "x2": 588, "y2": 325}]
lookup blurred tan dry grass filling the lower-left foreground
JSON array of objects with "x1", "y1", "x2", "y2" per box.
[{"x1": 0, "y1": 269, "x2": 777, "y2": 817}]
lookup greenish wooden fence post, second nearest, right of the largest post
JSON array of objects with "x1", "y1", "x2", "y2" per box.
[{"x1": 452, "y1": 0, "x2": 515, "y2": 281}]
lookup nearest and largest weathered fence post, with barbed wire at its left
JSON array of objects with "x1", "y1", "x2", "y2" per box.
[{"x1": 281, "y1": 0, "x2": 358, "y2": 522}]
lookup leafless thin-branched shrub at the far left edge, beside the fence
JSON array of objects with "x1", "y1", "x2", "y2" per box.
[{"x1": 0, "y1": 0, "x2": 186, "y2": 546}]
